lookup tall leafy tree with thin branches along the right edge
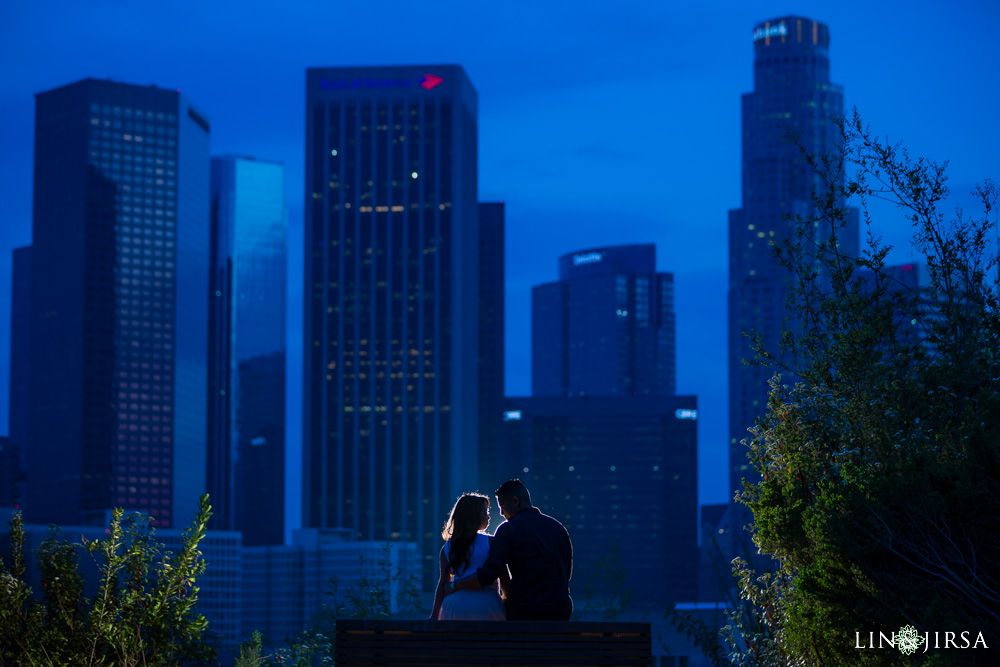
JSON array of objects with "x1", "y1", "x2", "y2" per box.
[{"x1": 729, "y1": 111, "x2": 1000, "y2": 665}]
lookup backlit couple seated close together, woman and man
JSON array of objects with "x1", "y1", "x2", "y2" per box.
[{"x1": 431, "y1": 479, "x2": 573, "y2": 621}]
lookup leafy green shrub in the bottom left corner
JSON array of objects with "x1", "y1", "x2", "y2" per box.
[{"x1": 0, "y1": 494, "x2": 216, "y2": 667}]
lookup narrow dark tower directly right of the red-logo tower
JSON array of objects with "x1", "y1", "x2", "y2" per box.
[{"x1": 477, "y1": 202, "x2": 505, "y2": 491}]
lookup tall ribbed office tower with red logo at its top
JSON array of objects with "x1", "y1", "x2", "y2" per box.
[{"x1": 302, "y1": 65, "x2": 479, "y2": 582}]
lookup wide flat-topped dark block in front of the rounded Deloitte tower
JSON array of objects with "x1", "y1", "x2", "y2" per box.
[{"x1": 494, "y1": 396, "x2": 698, "y2": 609}]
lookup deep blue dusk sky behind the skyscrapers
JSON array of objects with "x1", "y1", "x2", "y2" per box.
[{"x1": 0, "y1": 0, "x2": 1000, "y2": 525}]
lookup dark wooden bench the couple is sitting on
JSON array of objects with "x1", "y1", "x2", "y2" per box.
[{"x1": 334, "y1": 619, "x2": 653, "y2": 667}]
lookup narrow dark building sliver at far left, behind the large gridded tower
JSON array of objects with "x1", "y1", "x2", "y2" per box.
[{"x1": 7, "y1": 246, "x2": 31, "y2": 505}]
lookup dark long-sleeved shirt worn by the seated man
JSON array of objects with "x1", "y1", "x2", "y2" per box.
[{"x1": 476, "y1": 507, "x2": 573, "y2": 620}]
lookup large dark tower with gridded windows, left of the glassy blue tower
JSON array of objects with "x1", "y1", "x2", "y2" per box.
[{"x1": 25, "y1": 79, "x2": 209, "y2": 528}]
